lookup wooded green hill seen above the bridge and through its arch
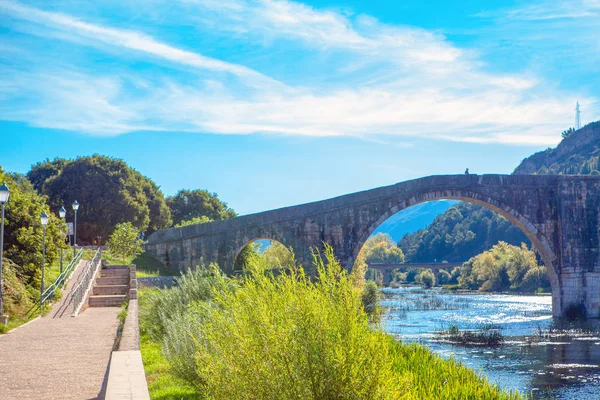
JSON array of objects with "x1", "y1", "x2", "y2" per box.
[{"x1": 398, "y1": 122, "x2": 600, "y2": 262}]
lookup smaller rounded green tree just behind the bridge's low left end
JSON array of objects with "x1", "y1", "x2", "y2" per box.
[{"x1": 167, "y1": 189, "x2": 237, "y2": 224}]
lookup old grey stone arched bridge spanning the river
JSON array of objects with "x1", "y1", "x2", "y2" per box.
[{"x1": 146, "y1": 175, "x2": 600, "y2": 318}]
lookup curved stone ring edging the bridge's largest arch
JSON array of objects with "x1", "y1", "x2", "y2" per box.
[{"x1": 345, "y1": 190, "x2": 561, "y2": 312}]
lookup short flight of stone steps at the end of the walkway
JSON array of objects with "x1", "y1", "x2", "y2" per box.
[{"x1": 88, "y1": 265, "x2": 129, "y2": 307}]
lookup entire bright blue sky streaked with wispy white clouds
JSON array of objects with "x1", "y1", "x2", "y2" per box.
[{"x1": 0, "y1": 0, "x2": 600, "y2": 214}]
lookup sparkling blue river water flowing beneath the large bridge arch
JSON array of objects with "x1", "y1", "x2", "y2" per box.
[{"x1": 382, "y1": 287, "x2": 600, "y2": 400}]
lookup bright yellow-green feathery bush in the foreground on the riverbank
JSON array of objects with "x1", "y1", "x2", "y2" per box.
[{"x1": 190, "y1": 248, "x2": 407, "y2": 400}]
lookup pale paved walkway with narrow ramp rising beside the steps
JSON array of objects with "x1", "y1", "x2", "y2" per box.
[{"x1": 0, "y1": 261, "x2": 120, "y2": 400}]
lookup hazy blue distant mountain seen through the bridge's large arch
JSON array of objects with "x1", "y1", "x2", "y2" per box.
[{"x1": 373, "y1": 200, "x2": 459, "y2": 242}]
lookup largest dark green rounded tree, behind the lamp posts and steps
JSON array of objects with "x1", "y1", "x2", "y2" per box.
[{"x1": 29, "y1": 155, "x2": 171, "y2": 243}]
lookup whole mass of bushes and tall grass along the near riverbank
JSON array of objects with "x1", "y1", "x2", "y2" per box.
[{"x1": 141, "y1": 248, "x2": 520, "y2": 400}]
